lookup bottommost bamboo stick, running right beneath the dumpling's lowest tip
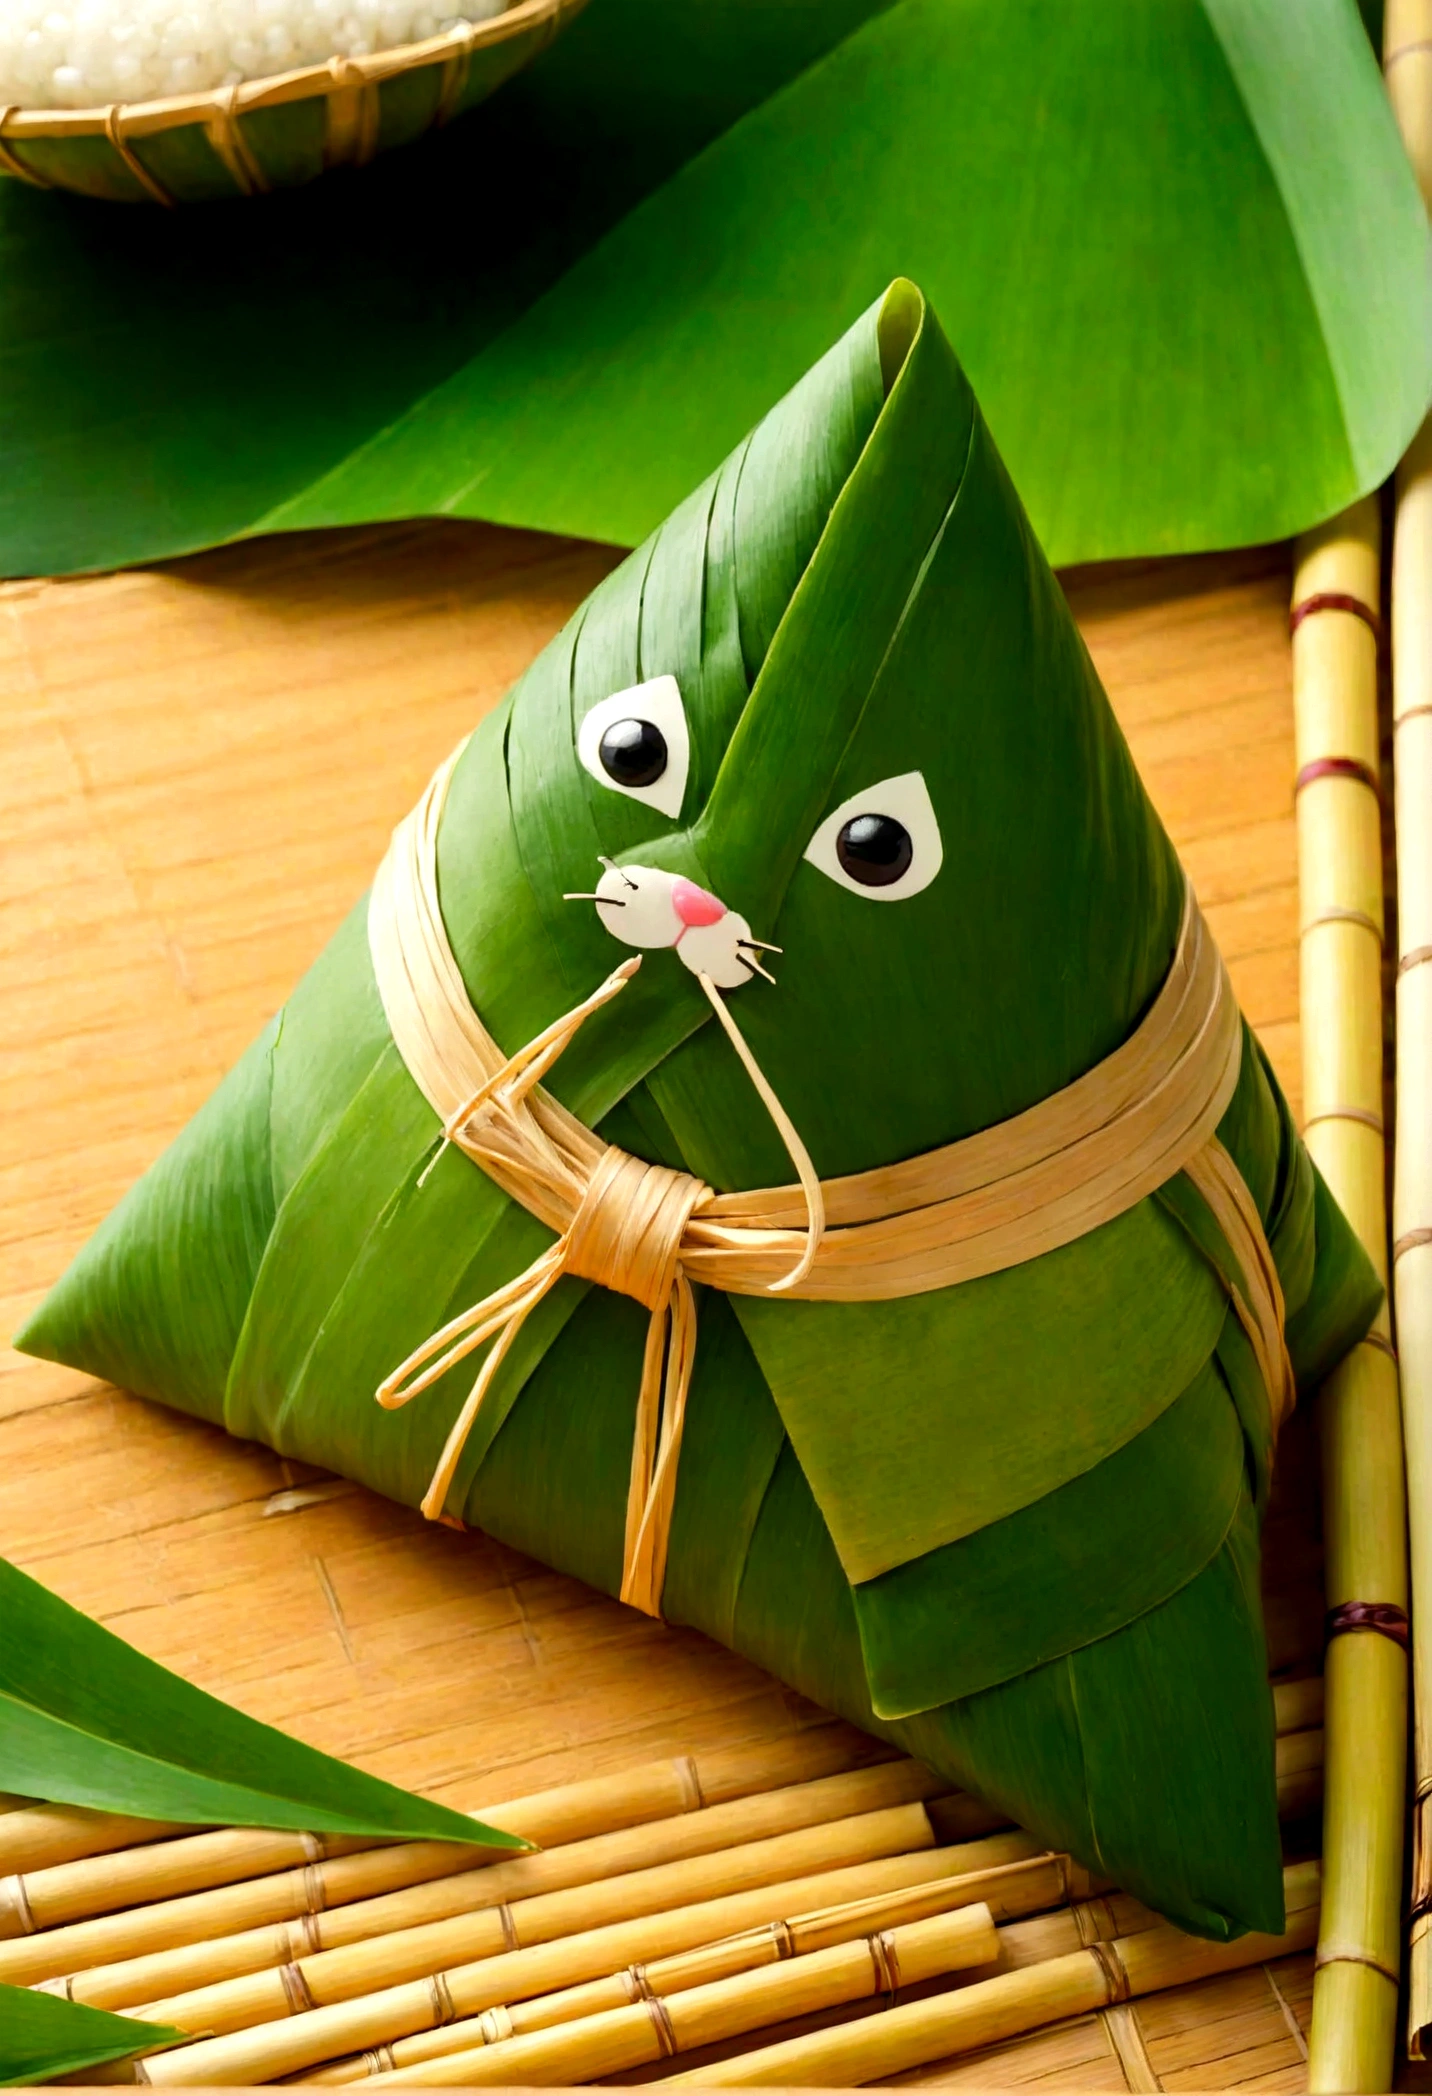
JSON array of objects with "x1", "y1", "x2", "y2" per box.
[{"x1": 658, "y1": 1872, "x2": 1319, "y2": 2088}]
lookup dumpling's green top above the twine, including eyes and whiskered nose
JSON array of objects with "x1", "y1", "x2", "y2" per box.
[{"x1": 431, "y1": 296, "x2": 1183, "y2": 1186}]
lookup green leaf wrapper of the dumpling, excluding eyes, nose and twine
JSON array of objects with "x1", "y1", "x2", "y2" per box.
[{"x1": 21, "y1": 283, "x2": 1380, "y2": 1937}]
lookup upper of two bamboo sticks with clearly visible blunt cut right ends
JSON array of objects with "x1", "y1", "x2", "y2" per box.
[{"x1": 44, "y1": 1761, "x2": 939, "y2": 2008}]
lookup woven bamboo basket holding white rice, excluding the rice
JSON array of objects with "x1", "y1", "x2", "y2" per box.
[{"x1": 0, "y1": 0, "x2": 585, "y2": 205}]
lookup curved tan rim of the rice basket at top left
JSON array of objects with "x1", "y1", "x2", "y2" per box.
[{"x1": 0, "y1": 0, "x2": 570, "y2": 145}]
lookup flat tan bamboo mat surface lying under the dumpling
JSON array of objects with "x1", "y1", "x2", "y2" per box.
[{"x1": 0, "y1": 524, "x2": 1321, "y2": 2090}]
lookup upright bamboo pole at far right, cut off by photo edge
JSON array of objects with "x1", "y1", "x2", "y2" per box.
[{"x1": 1384, "y1": 0, "x2": 1432, "y2": 2060}]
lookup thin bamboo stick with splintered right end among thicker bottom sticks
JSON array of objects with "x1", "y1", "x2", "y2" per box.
[{"x1": 306, "y1": 1853, "x2": 1107, "y2": 2086}]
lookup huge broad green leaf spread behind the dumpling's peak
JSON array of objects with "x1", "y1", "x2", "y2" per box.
[{"x1": 0, "y1": 0, "x2": 1432, "y2": 572}]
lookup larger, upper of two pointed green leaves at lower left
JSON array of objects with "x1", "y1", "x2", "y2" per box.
[{"x1": 0, "y1": 1559, "x2": 526, "y2": 1849}]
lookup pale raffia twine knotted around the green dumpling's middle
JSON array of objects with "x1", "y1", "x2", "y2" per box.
[{"x1": 369, "y1": 748, "x2": 1294, "y2": 1616}]
